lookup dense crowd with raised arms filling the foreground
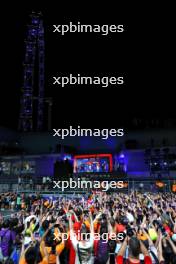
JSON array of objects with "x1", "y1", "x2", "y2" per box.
[{"x1": 0, "y1": 191, "x2": 176, "y2": 264}]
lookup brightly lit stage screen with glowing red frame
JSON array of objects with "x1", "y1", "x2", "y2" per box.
[{"x1": 74, "y1": 154, "x2": 112, "y2": 173}]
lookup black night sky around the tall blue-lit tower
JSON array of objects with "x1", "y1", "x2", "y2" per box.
[{"x1": 0, "y1": 1, "x2": 176, "y2": 128}]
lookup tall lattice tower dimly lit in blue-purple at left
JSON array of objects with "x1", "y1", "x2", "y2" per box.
[{"x1": 19, "y1": 13, "x2": 44, "y2": 131}]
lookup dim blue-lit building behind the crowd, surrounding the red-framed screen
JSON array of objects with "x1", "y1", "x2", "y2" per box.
[{"x1": 0, "y1": 128, "x2": 176, "y2": 191}]
